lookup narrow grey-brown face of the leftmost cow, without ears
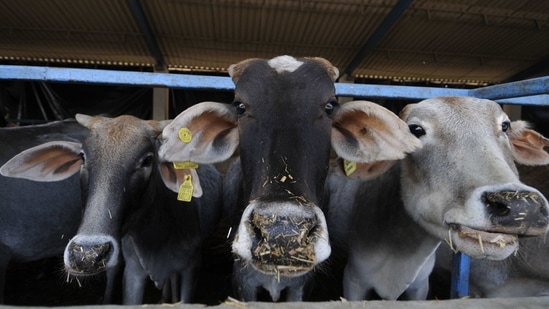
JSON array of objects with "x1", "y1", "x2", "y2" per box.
[{"x1": 65, "y1": 115, "x2": 167, "y2": 274}]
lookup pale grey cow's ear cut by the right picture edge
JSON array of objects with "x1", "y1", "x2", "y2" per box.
[{"x1": 506, "y1": 120, "x2": 549, "y2": 165}]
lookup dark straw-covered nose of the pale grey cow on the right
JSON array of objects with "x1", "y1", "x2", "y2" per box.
[{"x1": 482, "y1": 190, "x2": 549, "y2": 236}]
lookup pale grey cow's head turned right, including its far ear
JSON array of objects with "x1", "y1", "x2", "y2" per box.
[{"x1": 401, "y1": 97, "x2": 549, "y2": 259}]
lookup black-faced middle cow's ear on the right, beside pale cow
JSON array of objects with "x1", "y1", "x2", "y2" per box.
[{"x1": 332, "y1": 101, "x2": 422, "y2": 163}]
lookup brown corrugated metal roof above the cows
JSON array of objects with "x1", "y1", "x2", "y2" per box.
[{"x1": 0, "y1": 0, "x2": 549, "y2": 84}]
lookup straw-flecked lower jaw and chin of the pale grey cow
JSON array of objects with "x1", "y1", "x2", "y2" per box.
[{"x1": 448, "y1": 225, "x2": 519, "y2": 260}]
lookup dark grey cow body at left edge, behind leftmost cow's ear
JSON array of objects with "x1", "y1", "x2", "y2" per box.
[{"x1": 0, "y1": 120, "x2": 88, "y2": 303}]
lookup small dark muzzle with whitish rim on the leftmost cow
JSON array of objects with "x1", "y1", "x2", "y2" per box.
[{"x1": 64, "y1": 235, "x2": 119, "y2": 276}]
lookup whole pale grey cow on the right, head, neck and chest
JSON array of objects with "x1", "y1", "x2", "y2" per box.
[{"x1": 328, "y1": 97, "x2": 549, "y2": 300}]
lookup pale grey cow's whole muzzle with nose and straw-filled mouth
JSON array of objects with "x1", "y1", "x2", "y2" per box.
[{"x1": 445, "y1": 185, "x2": 549, "y2": 260}]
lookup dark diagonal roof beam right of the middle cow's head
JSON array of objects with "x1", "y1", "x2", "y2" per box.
[{"x1": 343, "y1": 0, "x2": 414, "y2": 76}]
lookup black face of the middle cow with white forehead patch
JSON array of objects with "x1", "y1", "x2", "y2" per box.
[{"x1": 231, "y1": 58, "x2": 337, "y2": 275}]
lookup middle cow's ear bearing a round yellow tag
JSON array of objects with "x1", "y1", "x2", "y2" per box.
[{"x1": 158, "y1": 102, "x2": 239, "y2": 164}]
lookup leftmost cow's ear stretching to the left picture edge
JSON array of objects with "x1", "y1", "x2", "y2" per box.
[{"x1": 0, "y1": 141, "x2": 82, "y2": 182}]
